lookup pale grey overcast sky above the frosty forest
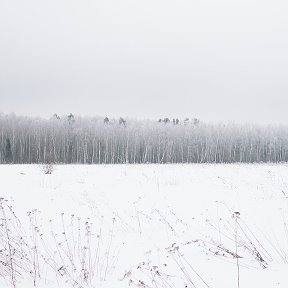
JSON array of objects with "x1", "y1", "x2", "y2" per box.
[{"x1": 0, "y1": 0, "x2": 288, "y2": 124}]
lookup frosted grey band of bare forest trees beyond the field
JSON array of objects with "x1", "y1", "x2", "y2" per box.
[{"x1": 0, "y1": 114, "x2": 288, "y2": 164}]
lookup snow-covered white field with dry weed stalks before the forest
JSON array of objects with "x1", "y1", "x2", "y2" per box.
[{"x1": 0, "y1": 164, "x2": 288, "y2": 288}]
